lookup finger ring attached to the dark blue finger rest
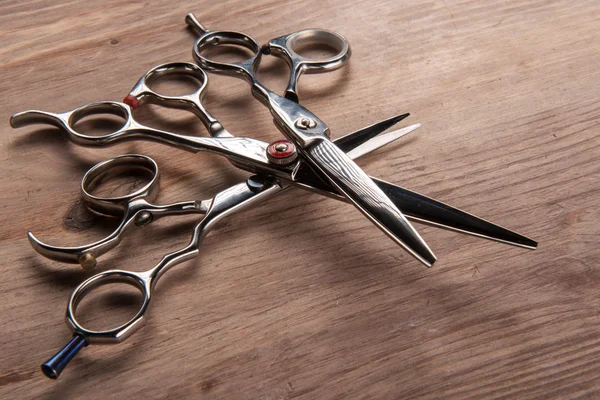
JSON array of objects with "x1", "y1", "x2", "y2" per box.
[{"x1": 66, "y1": 270, "x2": 152, "y2": 343}]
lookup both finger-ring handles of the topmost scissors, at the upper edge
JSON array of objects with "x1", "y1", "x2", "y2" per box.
[{"x1": 185, "y1": 14, "x2": 350, "y2": 102}]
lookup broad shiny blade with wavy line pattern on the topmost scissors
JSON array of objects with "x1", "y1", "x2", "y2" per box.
[{"x1": 302, "y1": 140, "x2": 436, "y2": 267}]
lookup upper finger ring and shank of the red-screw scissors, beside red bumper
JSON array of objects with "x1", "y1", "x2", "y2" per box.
[{"x1": 123, "y1": 62, "x2": 233, "y2": 137}]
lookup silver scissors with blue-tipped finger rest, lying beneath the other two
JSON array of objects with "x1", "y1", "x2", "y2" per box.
[{"x1": 35, "y1": 115, "x2": 415, "y2": 379}]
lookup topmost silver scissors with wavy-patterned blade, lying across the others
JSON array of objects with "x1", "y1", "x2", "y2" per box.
[{"x1": 186, "y1": 15, "x2": 436, "y2": 266}]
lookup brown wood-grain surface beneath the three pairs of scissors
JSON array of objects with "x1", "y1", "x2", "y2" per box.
[{"x1": 0, "y1": 0, "x2": 600, "y2": 399}]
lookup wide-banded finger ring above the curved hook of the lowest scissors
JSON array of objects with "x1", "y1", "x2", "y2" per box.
[{"x1": 81, "y1": 154, "x2": 160, "y2": 216}]
